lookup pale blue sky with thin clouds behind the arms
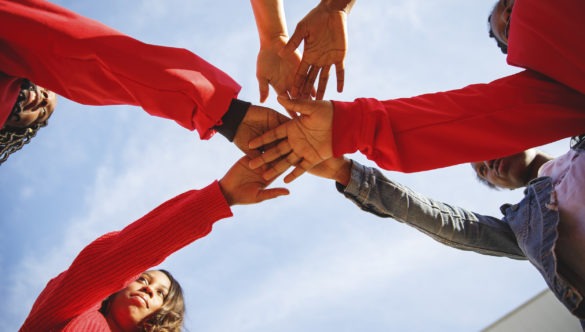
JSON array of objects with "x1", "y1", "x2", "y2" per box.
[{"x1": 0, "y1": 0, "x2": 568, "y2": 332}]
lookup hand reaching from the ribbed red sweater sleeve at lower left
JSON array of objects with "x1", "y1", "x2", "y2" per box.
[{"x1": 219, "y1": 156, "x2": 289, "y2": 206}]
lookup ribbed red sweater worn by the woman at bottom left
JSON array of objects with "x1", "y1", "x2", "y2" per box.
[{"x1": 20, "y1": 182, "x2": 232, "y2": 332}]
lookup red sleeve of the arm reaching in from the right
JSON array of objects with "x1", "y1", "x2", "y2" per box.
[{"x1": 333, "y1": 71, "x2": 585, "y2": 172}]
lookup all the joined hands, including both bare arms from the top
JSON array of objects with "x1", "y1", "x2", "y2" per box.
[{"x1": 220, "y1": 0, "x2": 355, "y2": 204}]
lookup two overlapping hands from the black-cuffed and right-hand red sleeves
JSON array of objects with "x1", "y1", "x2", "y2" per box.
[{"x1": 234, "y1": 96, "x2": 333, "y2": 183}]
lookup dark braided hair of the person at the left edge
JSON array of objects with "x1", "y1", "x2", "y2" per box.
[{"x1": 0, "y1": 79, "x2": 48, "y2": 165}]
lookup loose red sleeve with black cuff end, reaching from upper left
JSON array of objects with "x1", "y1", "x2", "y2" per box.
[{"x1": 0, "y1": 0, "x2": 240, "y2": 138}]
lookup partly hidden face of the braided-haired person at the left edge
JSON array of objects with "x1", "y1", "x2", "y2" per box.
[{"x1": 5, "y1": 85, "x2": 57, "y2": 128}]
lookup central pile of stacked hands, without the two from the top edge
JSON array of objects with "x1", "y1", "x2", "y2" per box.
[{"x1": 220, "y1": 96, "x2": 338, "y2": 205}]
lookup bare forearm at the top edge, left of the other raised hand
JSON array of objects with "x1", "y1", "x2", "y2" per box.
[{"x1": 250, "y1": 0, "x2": 288, "y2": 48}]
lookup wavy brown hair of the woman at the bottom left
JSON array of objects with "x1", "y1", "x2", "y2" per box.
[{"x1": 99, "y1": 270, "x2": 185, "y2": 332}]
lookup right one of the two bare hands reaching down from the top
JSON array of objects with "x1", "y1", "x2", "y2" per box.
[{"x1": 281, "y1": 2, "x2": 347, "y2": 100}]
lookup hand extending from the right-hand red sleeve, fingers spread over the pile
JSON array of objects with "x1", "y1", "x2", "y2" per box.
[{"x1": 249, "y1": 96, "x2": 333, "y2": 183}]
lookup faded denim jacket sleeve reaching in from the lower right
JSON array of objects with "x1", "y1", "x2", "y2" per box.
[{"x1": 338, "y1": 161, "x2": 524, "y2": 259}]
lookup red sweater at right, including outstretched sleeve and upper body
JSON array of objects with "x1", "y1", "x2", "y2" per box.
[{"x1": 333, "y1": 0, "x2": 585, "y2": 172}]
